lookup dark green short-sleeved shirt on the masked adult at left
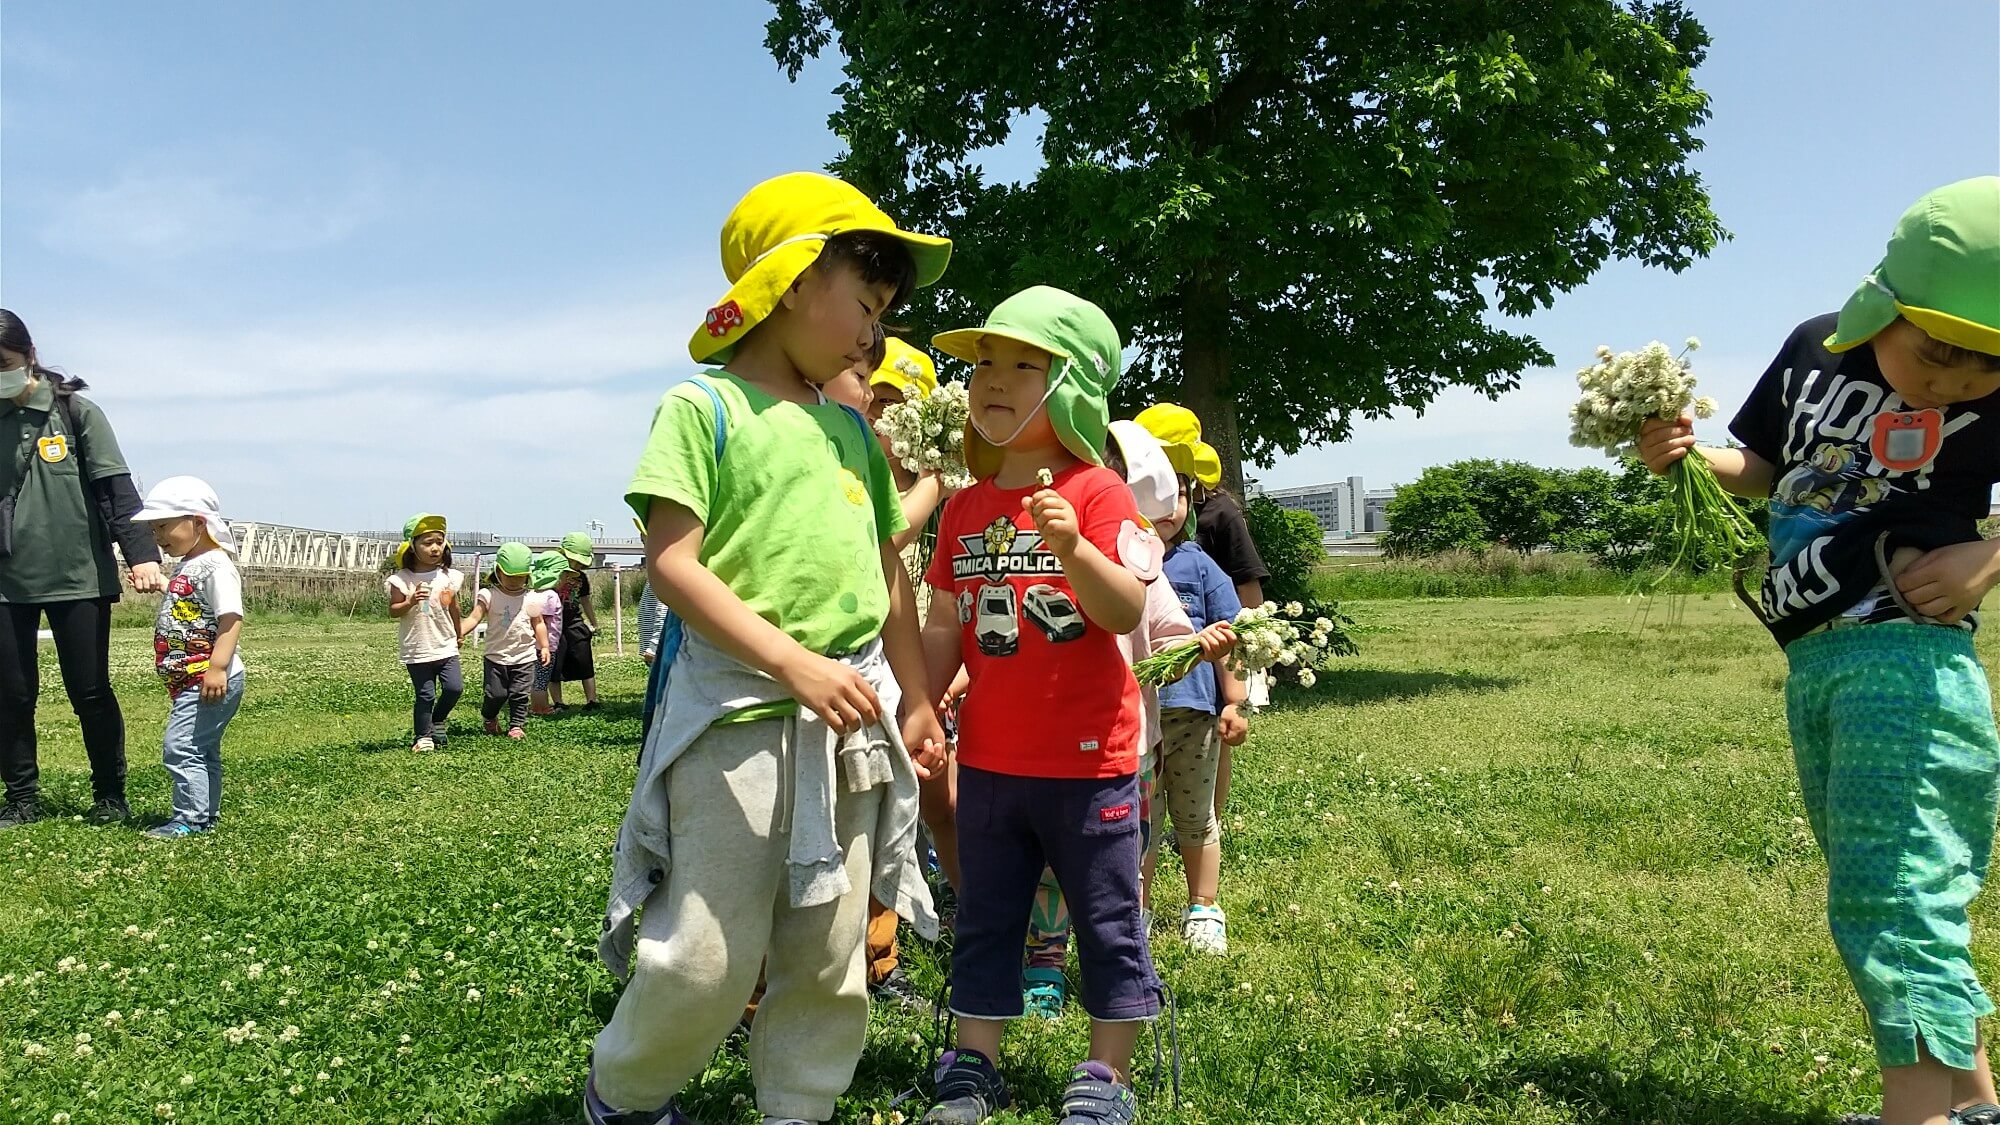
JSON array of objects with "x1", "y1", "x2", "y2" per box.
[{"x1": 0, "y1": 380, "x2": 130, "y2": 605}]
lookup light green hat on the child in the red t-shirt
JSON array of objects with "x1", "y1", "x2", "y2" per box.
[{"x1": 930, "y1": 284, "x2": 1124, "y2": 480}]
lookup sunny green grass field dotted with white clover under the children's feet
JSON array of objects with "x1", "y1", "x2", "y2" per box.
[{"x1": 0, "y1": 595, "x2": 1994, "y2": 1125}]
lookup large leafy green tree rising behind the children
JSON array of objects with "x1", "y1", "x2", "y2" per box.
[{"x1": 766, "y1": 0, "x2": 1724, "y2": 484}]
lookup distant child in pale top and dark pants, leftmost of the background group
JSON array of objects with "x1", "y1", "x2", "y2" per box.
[{"x1": 384, "y1": 512, "x2": 466, "y2": 753}]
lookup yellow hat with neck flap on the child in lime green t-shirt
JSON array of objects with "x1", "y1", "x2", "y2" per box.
[{"x1": 688, "y1": 172, "x2": 952, "y2": 362}]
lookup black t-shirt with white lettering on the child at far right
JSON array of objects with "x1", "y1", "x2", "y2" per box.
[{"x1": 1730, "y1": 312, "x2": 2000, "y2": 645}]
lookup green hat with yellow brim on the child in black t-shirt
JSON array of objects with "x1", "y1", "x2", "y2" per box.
[{"x1": 1826, "y1": 176, "x2": 2000, "y2": 356}]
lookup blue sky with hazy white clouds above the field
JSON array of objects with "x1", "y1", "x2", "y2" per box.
[{"x1": 0, "y1": 0, "x2": 2000, "y2": 532}]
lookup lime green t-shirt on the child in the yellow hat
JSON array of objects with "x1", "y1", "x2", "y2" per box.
[{"x1": 626, "y1": 370, "x2": 908, "y2": 655}]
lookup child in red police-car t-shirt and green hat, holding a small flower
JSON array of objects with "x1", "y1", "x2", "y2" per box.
[{"x1": 924, "y1": 286, "x2": 1160, "y2": 1125}]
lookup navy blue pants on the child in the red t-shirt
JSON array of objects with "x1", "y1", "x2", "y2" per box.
[{"x1": 952, "y1": 765, "x2": 1160, "y2": 1021}]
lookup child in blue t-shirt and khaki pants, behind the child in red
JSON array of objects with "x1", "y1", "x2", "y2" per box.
[{"x1": 1158, "y1": 468, "x2": 1250, "y2": 955}]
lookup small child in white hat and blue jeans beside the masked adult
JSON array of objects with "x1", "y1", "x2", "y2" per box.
[{"x1": 132, "y1": 476, "x2": 244, "y2": 839}]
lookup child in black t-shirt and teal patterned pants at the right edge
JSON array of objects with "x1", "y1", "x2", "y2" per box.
[{"x1": 1640, "y1": 176, "x2": 2000, "y2": 1125}]
